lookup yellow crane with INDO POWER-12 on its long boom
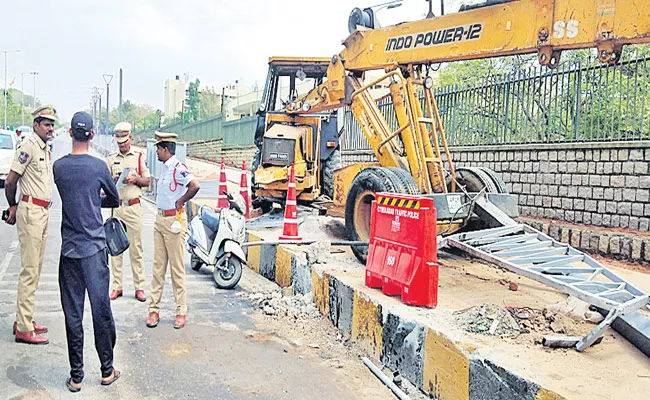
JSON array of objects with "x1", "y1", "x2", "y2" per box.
[{"x1": 256, "y1": 0, "x2": 650, "y2": 260}]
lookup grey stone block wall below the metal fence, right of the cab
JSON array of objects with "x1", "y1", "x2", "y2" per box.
[{"x1": 343, "y1": 141, "x2": 650, "y2": 232}]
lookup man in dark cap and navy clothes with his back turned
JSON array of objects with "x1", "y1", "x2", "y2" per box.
[{"x1": 54, "y1": 112, "x2": 120, "y2": 392}]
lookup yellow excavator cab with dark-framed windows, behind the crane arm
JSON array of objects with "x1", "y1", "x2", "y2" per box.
[{"x1": 252, "y1": 57, "x2": 341, "y2": 209}]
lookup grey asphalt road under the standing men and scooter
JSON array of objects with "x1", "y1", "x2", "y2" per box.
[{"x1": 0, "y1": 136, "x2": 391, "y2": 399}]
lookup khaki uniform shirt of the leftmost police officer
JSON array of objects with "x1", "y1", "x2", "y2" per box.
[{"x1": 11, "y1": 133, "x2": 52, "y2": 201}]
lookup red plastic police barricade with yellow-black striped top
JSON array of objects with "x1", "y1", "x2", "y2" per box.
[{"x1": 366, "y1": 193, "x2": 438, "y2": 307}]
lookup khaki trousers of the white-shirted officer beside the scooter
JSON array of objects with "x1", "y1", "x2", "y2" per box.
[{"x1": 149, "y1": 213, "x2": 187, "y2": 315}]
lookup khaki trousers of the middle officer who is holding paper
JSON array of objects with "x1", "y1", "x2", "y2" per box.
[{"x1": 111, "y1": 204, "x2": 144, "y2": 290}]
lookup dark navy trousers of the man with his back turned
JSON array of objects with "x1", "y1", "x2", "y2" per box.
[{"x1": 59, "y1": 249, "x2": 116, "y2": 383}]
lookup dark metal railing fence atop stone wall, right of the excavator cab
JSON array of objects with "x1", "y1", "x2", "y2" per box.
[{"x1": 342, "y1": 58, "x2": 650, "y2": 151}]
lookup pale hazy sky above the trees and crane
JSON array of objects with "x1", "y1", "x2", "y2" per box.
[{"x1": 0, "y1": 0, "x2": 466, "y2": 121}]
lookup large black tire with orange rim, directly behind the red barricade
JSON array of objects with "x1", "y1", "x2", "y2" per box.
[{"x1": 345, "y1": 167, "x2": 403, "y2": 264}]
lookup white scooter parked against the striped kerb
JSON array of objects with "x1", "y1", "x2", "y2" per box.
[{"x1": 186, "y1": 192, "x2": 246, "y2": 289}]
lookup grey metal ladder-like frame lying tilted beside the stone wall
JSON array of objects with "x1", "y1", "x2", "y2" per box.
[{"x1": 441, "y1": 195, "x2": 650, "y2": 356}]
